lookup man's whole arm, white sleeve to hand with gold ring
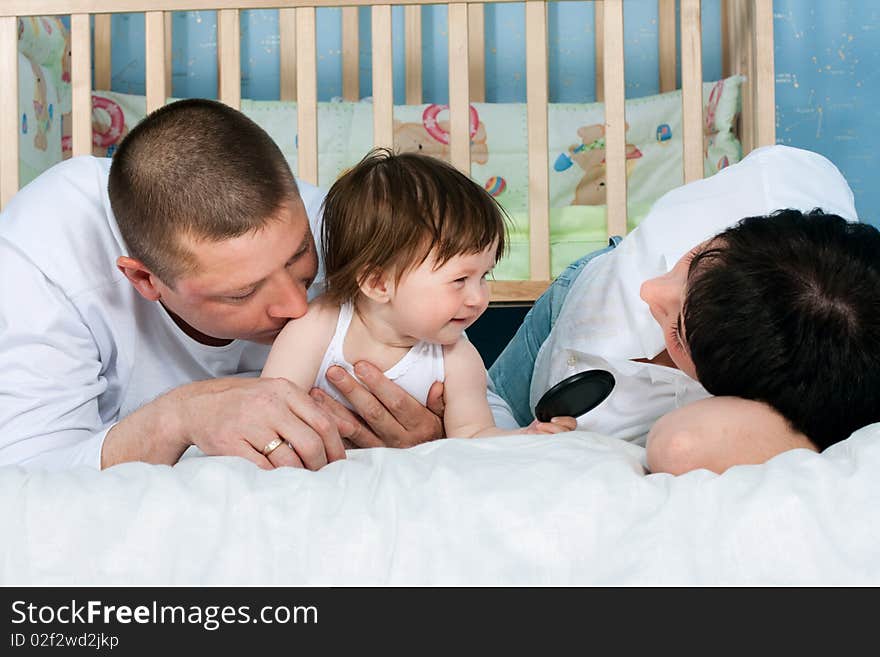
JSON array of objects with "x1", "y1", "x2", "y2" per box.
[{"x1": 0, "y1": 241, "x2": 345, "y2": 470}]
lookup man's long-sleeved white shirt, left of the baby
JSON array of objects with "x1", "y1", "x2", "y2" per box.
[{"x1": 0, "y1": 156, "x2": 516, "y2": 470}]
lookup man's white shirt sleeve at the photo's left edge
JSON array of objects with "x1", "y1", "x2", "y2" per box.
[{"x1": 0, "y1": 240, "x2": 117, "y2": 470}]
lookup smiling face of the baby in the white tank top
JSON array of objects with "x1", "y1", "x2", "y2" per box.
[{"x1": 391, "y1": 244, "x2": 497, "y2": 345}]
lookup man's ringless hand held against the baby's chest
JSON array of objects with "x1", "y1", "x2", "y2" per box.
[{"x1": 310, "y1": 361, "x2": 445, "y2": 447}]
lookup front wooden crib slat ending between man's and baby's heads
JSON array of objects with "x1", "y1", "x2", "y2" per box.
[{"x1": 296, "y1": 7, "x2": 318, "y2": 185}]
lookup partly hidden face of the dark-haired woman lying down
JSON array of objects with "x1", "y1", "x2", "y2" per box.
[{"x1": 639, "y1": 240, "x2": 709, "y2": 381}]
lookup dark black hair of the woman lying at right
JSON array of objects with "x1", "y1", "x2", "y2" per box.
[{"x1": 683, "y1": 209, "x2": 880, "y2": 450}]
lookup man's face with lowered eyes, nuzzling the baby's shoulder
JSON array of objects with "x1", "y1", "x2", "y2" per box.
[{"x1": 156, "y1": 201, "x2": 318, "y2": 344}]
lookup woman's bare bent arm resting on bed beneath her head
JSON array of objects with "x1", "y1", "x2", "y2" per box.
[{"x1": 647, "y1": 397, "x2": 817, "y2": 475}]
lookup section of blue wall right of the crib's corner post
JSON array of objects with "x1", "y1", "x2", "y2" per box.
[{"x1": 773, "y1": 0, "x2": 880, "y2": 226}]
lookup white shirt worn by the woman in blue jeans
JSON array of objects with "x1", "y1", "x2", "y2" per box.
[{"x1": 530, "y1": 146, "x2": 856, "y2": 444}]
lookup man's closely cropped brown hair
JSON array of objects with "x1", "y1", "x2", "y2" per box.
[{"x1": 108, "y1": 99, "x2": 299, "y2": 285}]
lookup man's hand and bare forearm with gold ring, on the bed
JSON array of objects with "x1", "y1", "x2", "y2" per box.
[{"x1": 102, "y1": 378, "x2": 345, "y2": 470}]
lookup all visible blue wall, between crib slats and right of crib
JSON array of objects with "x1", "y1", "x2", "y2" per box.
[{"x1": 99, "y1": 0, "x2": 880, "y2": 226}]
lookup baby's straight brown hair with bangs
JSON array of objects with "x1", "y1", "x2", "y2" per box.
[{"x1": 322, "y1": 148, "x2": 506, "y2": 303}]
